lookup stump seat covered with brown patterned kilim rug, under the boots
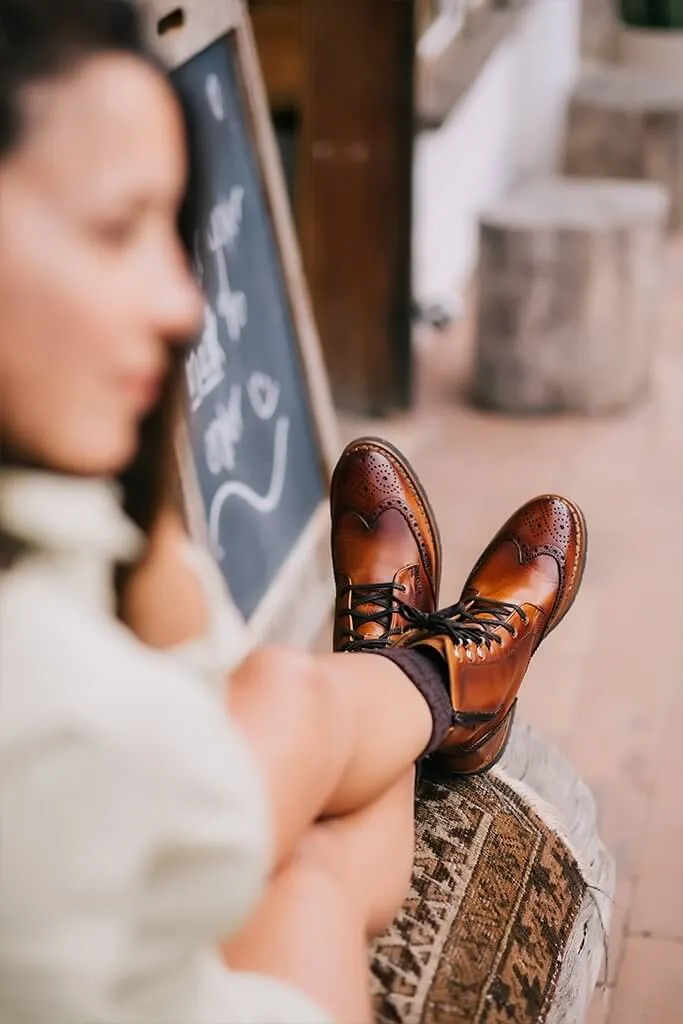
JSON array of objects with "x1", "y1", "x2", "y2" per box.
[{"x1": 373, "y1": 725, "x2": 614, "y2": 1024}]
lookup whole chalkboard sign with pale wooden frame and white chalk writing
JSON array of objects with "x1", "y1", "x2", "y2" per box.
[{"x1": 145, "y1": 0, "x2": 334, "y2": 640}]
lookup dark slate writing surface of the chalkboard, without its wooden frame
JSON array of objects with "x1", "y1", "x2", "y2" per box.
[{"x1": 174, "y1": 40, "x2": 326, "y2": 618}]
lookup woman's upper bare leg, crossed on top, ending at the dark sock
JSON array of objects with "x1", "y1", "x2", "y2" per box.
[{"x1": 229, "y1": 648, "x2": 432, "y2": 864}]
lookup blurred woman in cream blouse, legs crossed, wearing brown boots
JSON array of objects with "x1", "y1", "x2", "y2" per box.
[{"x1": 0, "y1": 0, "x2": 584, "y2": 1024}]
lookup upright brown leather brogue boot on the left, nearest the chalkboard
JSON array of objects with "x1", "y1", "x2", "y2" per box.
[{"x1": 331, "y1": 437, "x2": 441, "y2": 651}]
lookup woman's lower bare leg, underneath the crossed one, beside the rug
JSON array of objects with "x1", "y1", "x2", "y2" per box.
[{"x1": 224, "y1": 771, "x2": 414, "y2": 1024}]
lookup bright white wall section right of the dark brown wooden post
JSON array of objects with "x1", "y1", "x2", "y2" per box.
[{"x1": 413, "y1": 0, "x2": 581, "y2": 304}]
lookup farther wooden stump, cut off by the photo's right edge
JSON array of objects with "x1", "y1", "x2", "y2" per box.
[{"x1": 564, "y1": 68, "x2": 683, "y2": 231}]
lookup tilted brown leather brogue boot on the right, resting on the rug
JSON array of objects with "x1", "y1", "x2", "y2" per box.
[{"x1": 398, "y1": 495, "x2": 586, "y2": 775}]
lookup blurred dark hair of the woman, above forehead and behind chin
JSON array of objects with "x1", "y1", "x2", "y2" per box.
[{"x1": 0, "y1": 0, "x2": 194, "y2": 552}]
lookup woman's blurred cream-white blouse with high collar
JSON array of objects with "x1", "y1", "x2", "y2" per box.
[{"x1": 0, "y1": 471, "x2": 328, "y2": 1024}]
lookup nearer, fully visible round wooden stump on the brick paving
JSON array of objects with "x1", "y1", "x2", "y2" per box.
[{"x1": 474, "y1": 177, "x2": 669, "y2": 415}]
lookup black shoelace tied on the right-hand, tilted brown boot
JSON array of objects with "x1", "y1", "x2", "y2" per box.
[{"x1": 399, "y1": 597, "x2": 528, "y2": 650}]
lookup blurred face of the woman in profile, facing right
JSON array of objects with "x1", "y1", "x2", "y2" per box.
[{"x1": 0, "y1": 54, "x2": 201, "y2": 475}]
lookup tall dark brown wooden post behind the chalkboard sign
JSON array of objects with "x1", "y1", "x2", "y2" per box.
[{"x1": 299, "y1": 0, "x2": 415, "y2": 416}]
